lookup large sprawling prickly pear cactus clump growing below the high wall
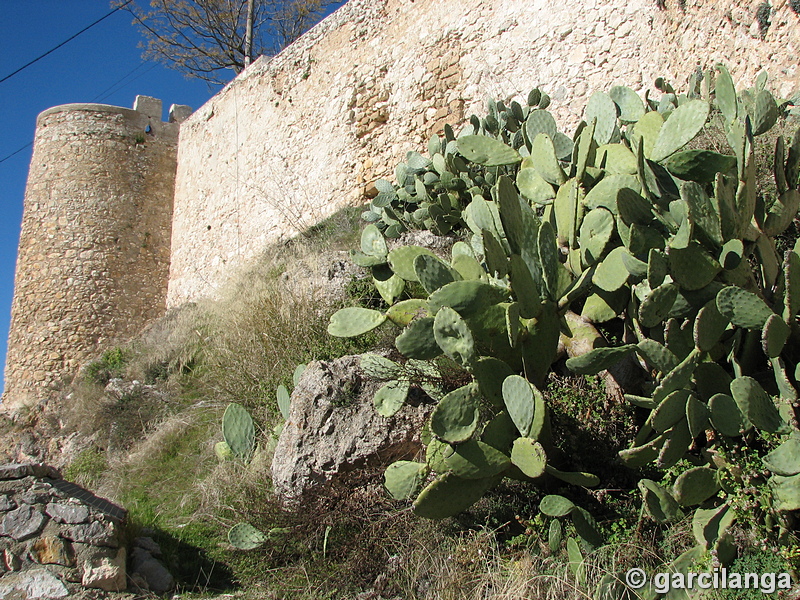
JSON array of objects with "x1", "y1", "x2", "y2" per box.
[{"x1": 329, "y1": 66, "x2": 800, "y2": 544}]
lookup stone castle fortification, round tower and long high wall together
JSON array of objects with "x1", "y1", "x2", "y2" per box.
[{"x1": 2, "y1": 0, "x2": 800, "y2": 412}]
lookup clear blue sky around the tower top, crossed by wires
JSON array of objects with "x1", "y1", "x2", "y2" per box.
[{"x1": 0, "y1": 0, "x2": 344, "y2": 394}]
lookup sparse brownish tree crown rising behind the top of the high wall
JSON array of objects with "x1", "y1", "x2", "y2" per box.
[{"x1": 122, "y1": 0, "x2": 343, "y2": 83}]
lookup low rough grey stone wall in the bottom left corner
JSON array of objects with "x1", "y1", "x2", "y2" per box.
[{"x1": 0, "y1": 464, "x2": 128, "y2": 600}]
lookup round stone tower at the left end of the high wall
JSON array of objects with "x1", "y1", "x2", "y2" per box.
[{"x1": 1, "y1": 96, "x2": 191, "y2": 412}]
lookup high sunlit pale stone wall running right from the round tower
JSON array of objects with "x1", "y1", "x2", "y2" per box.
[{"x1": 168, "y1": 0, "x2": 800, "y2": 305}]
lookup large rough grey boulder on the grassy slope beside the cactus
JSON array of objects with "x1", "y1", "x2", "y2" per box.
[{"x1": 272, "y1": 356, "x2": 433, "y2": 504}]
